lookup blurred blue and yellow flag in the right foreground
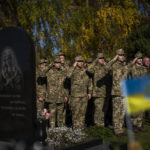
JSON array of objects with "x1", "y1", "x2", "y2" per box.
[{"x1": 121, "y1": 76, "x2": 150, "y2": 114}]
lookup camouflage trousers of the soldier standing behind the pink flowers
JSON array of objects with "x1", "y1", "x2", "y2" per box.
[{"x1": 48, "y1": 103, "x2": 66, "y2": 128}]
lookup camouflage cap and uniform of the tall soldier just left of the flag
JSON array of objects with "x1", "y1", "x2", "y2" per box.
[{"x1": 107, "y1": 49, "x2": 128, "y2": 134}]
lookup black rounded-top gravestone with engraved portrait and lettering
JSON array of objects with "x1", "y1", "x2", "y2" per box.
[{"x1": 0, "y1": 27, "x2": 36, "y2": 140}]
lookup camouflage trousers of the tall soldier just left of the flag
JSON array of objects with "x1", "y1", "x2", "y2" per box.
[{"x1": 112, "y1": 96, "x2": 125, "y2": 134}]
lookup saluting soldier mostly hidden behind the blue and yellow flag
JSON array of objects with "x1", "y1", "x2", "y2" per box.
[{"x1": 130, "y1": 52, "x2": 147, "y2": 131}]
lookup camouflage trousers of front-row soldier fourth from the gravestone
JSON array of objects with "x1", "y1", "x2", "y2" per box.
[{"x1": 94, "y1": 97, "x2": 105, "y2": 126}]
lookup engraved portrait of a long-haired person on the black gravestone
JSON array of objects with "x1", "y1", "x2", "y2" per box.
[{"x1": 0, "y1": 47, "x2": 23, "y2": 94}]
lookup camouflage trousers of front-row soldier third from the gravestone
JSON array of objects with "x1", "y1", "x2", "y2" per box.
[{"x1": 70, "y1": 97, "x2": 88, "y2": 128}]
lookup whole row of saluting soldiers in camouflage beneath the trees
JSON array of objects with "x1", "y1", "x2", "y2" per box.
[{"x1": 36, "y1": 49, "x2": 150, "y2": 136}]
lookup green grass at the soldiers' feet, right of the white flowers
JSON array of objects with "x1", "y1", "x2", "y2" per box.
[{"x1": 85, "y1": 121, "x2": 150, "y2": 150}]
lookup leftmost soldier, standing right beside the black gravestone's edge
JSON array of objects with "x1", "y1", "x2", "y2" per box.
[{"x1": 36, "y1": 59, "x2": 46, "y2": 117}]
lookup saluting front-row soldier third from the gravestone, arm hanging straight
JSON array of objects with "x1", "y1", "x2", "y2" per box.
[{"x1": 68, "y1": 56, "x2": 92, "y2": 129}]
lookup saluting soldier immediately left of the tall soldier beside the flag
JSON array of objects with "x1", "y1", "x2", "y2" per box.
[{"x1": 88, "y1": 53, "x2": 108, "y2": 126}]
